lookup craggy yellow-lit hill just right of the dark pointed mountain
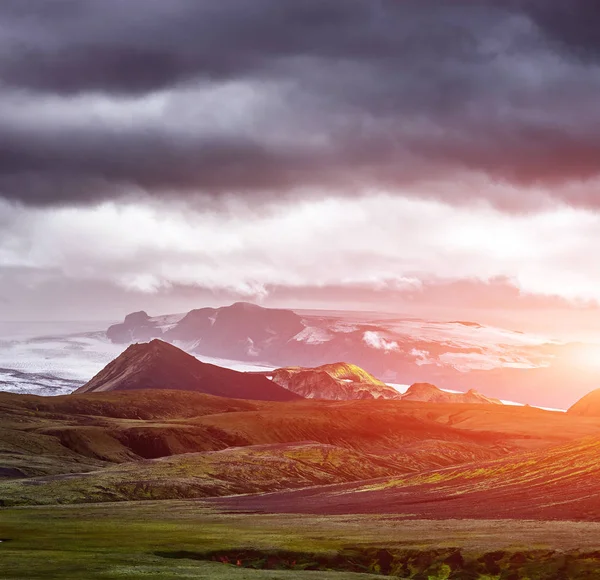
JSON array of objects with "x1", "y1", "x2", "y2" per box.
[{"x1": 272, "y1": 363, "x2": 401, "y2": 401}]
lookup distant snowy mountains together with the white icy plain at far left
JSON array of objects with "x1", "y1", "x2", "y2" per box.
[{"x1": 0, "y1": 303, "x2": 600, "y2": 408}]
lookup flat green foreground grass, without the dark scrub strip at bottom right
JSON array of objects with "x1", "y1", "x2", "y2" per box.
[{"x1": 0, "y1": 502, "x2": 600, "y2": 580}]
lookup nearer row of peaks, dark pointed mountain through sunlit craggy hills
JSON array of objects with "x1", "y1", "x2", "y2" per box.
[{"x1": 76, "y1": 339, "x2": 500, "y2": 404}]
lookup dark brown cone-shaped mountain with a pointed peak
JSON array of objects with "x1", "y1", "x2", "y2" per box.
[{"x1": 76, "y1": 339, "x2": 301, "y2": 401}]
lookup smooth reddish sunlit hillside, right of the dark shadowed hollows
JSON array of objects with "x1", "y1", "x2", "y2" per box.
[{"x1": 193, "y1": 400, "x2": 572, "y2": 453}]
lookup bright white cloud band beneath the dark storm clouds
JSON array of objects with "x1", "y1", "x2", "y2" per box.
[{"x1": 0, "y1": 193, "x2": 600, "y2": 308}]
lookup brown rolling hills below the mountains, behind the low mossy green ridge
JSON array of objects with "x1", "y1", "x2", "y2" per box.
[{"x1": 0, "y1": 390, "x2": 600, "y2": 488}]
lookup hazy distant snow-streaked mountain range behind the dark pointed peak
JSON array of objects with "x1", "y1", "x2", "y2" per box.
[{"x1": 106, "y1": 302, "x2": 568, "y2": 407}]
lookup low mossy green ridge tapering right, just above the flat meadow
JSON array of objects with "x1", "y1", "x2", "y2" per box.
[{"x1": 0, "y1": 443, "x2": 406, "y2": 506}]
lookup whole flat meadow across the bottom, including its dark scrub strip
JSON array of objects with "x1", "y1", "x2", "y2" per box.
[{"x1": 0, "y1": 501, "x2": 600, "y2": 580}]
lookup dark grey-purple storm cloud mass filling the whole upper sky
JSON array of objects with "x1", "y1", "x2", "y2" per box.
[{"x1": 0, "y1": 0, "x2": 600, "y2": 206}]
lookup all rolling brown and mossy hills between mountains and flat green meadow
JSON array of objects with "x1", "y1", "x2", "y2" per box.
[{"x1": 0, "y1": 390, "x2": 600, "y2": 513}]
